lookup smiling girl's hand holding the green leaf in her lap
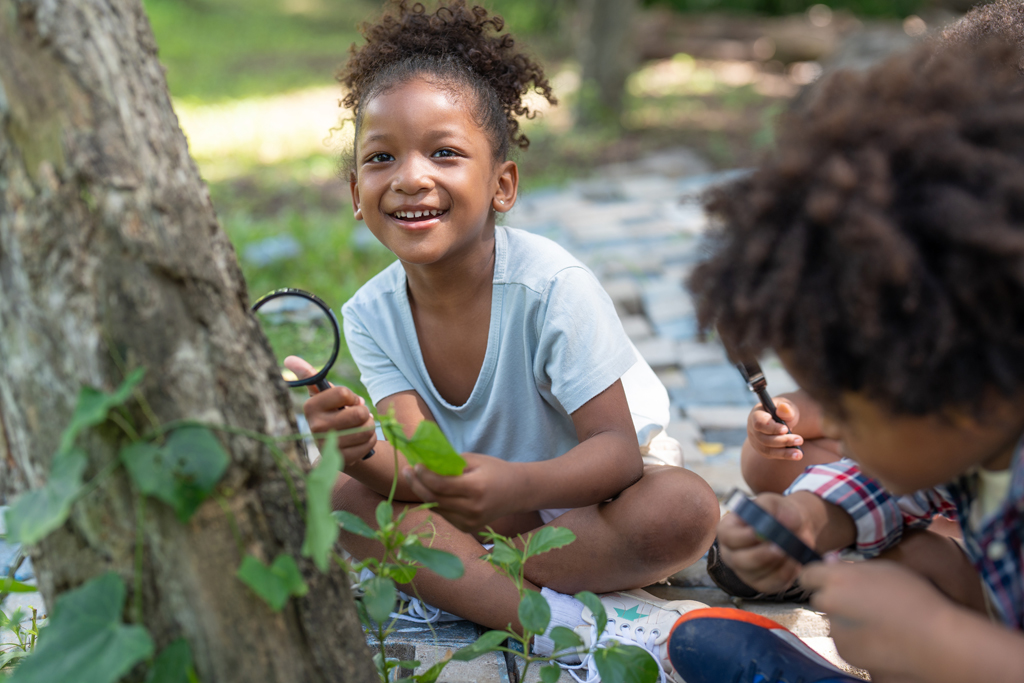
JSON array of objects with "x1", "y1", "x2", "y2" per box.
[{"x1": 402, "y1": 453, "x2": 519, "y2": 531}]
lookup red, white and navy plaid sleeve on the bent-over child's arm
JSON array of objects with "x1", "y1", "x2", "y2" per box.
[{"x1": 785, "y1": 458, "x2": 956, "y2": 557}]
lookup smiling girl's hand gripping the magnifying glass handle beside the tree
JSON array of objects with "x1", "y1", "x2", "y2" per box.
[{"x1": 285, "y1": 355, "x2": 377, "y2": 466}]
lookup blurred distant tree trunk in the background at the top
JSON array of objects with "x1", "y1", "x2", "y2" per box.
[{"x1": 577, "y1": 0, "x2": 637, "y2": 126}]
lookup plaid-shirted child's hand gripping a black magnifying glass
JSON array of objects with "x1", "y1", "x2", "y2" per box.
[{"x1": 718, "y1": 491, "x2": 814, "y2": 593}]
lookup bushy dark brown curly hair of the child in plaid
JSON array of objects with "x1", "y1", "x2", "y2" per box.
[{"x1": 689, "y1": 42, "x2": 1024, "y2": 415}]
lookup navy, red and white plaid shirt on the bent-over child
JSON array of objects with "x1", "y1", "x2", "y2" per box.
[{"x1": 785, "y1": 439, "x2": 1024, "y2": 630}]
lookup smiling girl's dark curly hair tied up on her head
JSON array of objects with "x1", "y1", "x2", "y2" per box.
[{"x1": 337, "y1": 0, "x2": 557, "y2": 159}]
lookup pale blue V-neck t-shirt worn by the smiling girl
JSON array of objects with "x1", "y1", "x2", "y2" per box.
[{"x1": 341, "y1": 225, "x2": 669, "y2": 462}]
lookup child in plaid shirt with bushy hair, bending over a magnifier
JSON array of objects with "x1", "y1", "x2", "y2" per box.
[{"x1": 673, "y1": 34, "x2": 1024, "y2": 683}]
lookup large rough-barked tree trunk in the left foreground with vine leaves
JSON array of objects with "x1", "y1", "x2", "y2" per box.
[{"x1": 0, "y1": 0, "x2": 376, "y2": 683}]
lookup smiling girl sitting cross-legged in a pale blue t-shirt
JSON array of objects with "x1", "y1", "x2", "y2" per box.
[{"x1": 292, "y1": 1, "x2": 719, "y2": 679}]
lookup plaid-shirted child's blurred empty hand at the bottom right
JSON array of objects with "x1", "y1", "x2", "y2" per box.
[{"x1": 800, "y1": 560, "x2": 966, "y2": 681}]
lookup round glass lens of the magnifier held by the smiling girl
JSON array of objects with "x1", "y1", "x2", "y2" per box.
[{"x1": 256, "y1": 294, "x2": 335, "y2": 382}]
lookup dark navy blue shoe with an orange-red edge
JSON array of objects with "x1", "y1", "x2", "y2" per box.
[{"x1": 669, "y1": 607, "x2": 862, "y2": 683}]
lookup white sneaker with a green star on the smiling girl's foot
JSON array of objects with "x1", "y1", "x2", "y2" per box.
[{"x1": 569, "y1": 589, "x2": 708, "y2": 683}]
